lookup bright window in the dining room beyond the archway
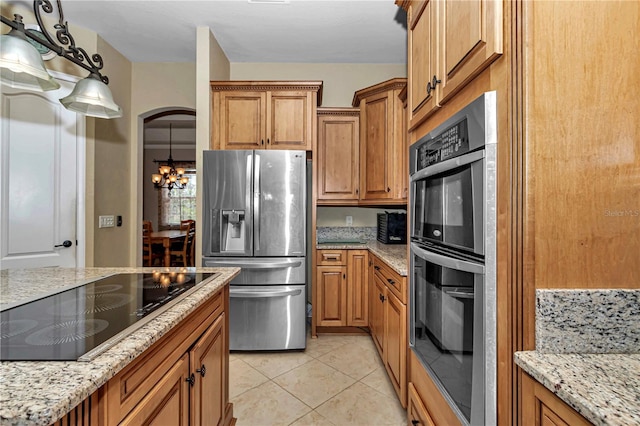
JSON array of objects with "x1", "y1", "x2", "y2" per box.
[{"x1": 158, "y1": 169, "x2": 196, "y2": 229}]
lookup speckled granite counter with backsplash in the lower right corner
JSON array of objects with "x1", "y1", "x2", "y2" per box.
[{"x1": 515, "y1": 289, "x2": 640, "y2": 425}]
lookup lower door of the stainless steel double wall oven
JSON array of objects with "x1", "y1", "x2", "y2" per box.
[{"x1": 409, "y1": 242, "x2": 487, "y2": 425}]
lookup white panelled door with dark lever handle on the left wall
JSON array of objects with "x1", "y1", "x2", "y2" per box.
[{"x1": 0, "y1": 79, "x2": 84, "y2": 269}]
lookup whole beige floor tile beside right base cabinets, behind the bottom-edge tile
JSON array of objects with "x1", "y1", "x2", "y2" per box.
[{"x1": 318, "y1": 344, "x2": 382, "y2": 380}]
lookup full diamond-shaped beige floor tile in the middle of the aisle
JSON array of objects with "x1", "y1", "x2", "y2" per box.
[{"x1": 273, "y1": 360, "x2": 355, "y2": 408}]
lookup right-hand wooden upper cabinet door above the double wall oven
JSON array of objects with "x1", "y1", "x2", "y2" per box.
[{"x1": 438, "y1": 0, "x2": 502, "y2": 102}]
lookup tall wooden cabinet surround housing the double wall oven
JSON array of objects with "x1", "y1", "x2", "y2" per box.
[{"x1": 396, "y1": 0, "x2": 640, "y2": 425}]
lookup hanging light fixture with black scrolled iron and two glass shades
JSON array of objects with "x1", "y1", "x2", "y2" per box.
[{"x1": 0, "y1": 0, "x2": 122, "y2": 118}]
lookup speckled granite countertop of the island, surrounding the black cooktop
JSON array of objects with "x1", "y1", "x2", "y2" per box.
[{"x1": 0, "y1": 268, "x2": 240, "y2": 425}]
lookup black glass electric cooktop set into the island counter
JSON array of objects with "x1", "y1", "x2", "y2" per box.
[{"x1": 0, "y1": 272, "x2": 217, "y2": 361}]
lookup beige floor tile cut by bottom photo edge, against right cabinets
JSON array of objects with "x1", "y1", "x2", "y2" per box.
[{"x1": 316, "y1": 382, "x2": 406, "y2": 426}]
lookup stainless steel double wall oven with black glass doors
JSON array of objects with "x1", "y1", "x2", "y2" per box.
[{"x1": 409, "y1": 92, "x2": 497, "y2": 425}]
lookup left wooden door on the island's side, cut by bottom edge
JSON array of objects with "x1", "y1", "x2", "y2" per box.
[{"x1": 120, "y1": 354, "x2": 189, "y2": 426}]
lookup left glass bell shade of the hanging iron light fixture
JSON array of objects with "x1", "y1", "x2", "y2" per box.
[{"x1": 0, "y1": 30, "x2": 60, "y2": 92}]
